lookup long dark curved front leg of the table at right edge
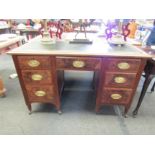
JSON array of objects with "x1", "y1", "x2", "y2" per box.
[{"x1": 133, "y1": 74, "x2": 154, "y2": 116}]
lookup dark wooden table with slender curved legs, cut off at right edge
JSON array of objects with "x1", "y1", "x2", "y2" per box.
[{"x1": 133, "y1": 47, "x2": 155, "y2": 116}]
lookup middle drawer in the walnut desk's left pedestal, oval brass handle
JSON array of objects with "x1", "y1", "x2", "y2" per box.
[{"x1": 21, "y1": 70, "x2": 52, "y2": 84}]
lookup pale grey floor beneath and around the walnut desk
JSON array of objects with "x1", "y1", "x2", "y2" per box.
[{"x1": 0, "y1": 54, "x2": 155, "y2": 135}]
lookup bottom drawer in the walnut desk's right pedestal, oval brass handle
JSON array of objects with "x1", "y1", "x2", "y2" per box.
[{"x1": 101, "y1": 88, "x2": 132, "y2": 104}]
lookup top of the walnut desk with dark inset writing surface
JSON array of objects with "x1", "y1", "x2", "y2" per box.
[{"x1": 8, "y1": 36, "x2": 151, "y2": 58}]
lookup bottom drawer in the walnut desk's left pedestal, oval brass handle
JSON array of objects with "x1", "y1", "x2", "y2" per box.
[{"x1": 26, "y1": 85, "x2": 54, "y2": 102}]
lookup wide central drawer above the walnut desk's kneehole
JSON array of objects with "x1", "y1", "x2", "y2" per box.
[{"x1": 56, "y1": 57, "x2": 101, "y2": 70}]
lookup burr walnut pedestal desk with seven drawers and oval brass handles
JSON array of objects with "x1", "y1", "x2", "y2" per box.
[{"x1": 8, "y1": 36, "x2": 150, "y2": 114}]
